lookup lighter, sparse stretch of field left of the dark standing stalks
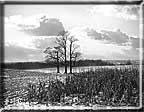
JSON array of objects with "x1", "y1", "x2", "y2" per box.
[{"x1": 4, "y1": 69, "x2": 66, "y2": 102}]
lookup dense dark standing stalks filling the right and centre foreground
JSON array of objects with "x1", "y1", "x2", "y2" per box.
[{"x1": 26, "y1": 67, "x2": 139, "y2": 106}]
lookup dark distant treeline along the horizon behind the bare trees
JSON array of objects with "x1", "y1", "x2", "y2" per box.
[{"x1": 2, "y1": 60, "x2": 114, "y2": 69}]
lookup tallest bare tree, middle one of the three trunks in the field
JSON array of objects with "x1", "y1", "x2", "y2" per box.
[{"x1": 56, "y1": 31, "x2": 69, "y2": 73}]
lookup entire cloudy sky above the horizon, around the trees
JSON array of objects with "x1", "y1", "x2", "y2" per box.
[{"x1": 4, "y1": 5, "x2": 140, "y2": 62}]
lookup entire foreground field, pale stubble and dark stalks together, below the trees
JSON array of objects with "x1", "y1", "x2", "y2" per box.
[{"x1": 2, "y1": 67, "x2": 139, "y2": 106}]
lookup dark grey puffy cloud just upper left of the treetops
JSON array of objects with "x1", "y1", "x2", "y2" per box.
[{"x1": 19, "y1": 16, "x2": 64, "y2": 36}]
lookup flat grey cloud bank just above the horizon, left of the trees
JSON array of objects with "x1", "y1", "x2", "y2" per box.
[{"x1": 4, "y1": 45, "x2": 42, "y2": 62}]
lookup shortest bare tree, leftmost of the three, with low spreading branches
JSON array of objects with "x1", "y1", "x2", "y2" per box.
[{"x1": 44, "y1": 46, "x2": 61, "y2": 73}]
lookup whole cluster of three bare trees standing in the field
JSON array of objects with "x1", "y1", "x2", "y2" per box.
[{"x1": 44, "y1": 31, "x2": 81, "y2": 73}]
